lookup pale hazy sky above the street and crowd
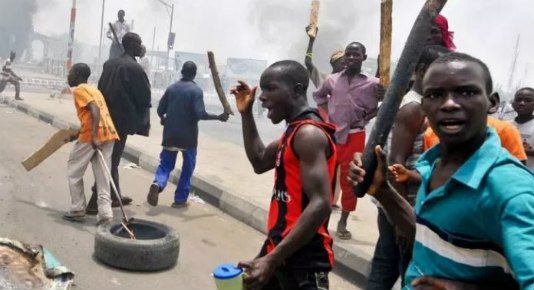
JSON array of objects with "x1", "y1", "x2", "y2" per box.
[{"x1": 28, "y1": 0, "x2": 534, "y2": 97}]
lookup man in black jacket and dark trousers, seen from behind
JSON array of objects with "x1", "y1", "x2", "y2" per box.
[{"x1": 87, "y1": 32, "x2": 151, "y2": 213}]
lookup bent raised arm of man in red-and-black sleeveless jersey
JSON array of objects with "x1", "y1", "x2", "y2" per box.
[{"x1": 231, "y1": 81, "x2": 278, "y2": 174}]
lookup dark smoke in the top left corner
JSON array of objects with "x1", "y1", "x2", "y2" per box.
[{"x1": 0, "y1": 0, "x2": 37, "y2": 58}]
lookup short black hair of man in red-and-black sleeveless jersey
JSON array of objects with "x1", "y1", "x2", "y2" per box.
[{"x1": 265, "y1": 60, "x2": 310, "y2": 95}]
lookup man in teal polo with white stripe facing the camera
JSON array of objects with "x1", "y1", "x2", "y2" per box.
[{"x1": 350, "y1": 53, "x2": 534, "y2": 289}]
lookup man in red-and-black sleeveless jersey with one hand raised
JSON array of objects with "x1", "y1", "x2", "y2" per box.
[{"x1": 232, "y1": 60, "x2": 336, "y2": 290}]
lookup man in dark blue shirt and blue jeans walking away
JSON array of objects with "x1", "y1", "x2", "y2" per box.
[{"x1": 147, "y1": 61, "x2": 228, "y2": 208}]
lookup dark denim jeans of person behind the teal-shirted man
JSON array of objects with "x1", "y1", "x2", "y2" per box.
[{"x1": 366, "y1": 209, "x2": 412, "y2": 290}]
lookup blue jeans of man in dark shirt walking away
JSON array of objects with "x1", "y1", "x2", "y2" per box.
[{"x1": 154, "y1": 148, "x2": 197, "y2": 203}]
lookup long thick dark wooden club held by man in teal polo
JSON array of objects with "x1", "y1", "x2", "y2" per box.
[{"x1": 353, "y1": 0, "x2": 447, "y2": 197}]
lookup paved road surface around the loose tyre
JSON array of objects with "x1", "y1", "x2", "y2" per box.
[{"x1": 0, "y1": 106, "x2": 360, "y2": 290}]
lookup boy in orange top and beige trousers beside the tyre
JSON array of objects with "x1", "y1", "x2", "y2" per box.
[{"x1": 63, "y1": 63, "x2": 118, "y2": 225}]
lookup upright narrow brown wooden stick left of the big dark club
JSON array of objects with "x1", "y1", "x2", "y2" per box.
[{"x1": 380, "y1": 0, "x2": 393, "y2": 87}]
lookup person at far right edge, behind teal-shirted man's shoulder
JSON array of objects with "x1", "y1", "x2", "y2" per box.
[{"x1": 512, "y1": 87, "x2": 534, "y2": 170}]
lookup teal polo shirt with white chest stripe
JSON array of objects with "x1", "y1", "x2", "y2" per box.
[{"x1": 405, "y1": 128, "x2": 534, "y2": 289}]
